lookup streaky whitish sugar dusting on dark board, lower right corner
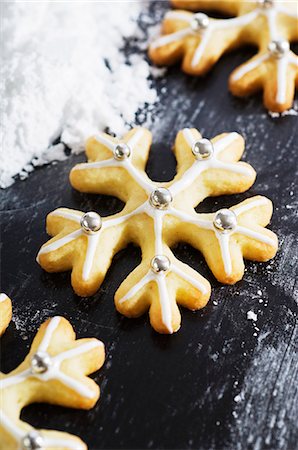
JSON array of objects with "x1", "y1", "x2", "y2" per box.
[{"x1": 230, "y1": 325, "x2": 298, "y2": 450}]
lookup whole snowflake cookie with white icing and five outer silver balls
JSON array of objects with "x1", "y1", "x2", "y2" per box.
[{"x1": 37, "y1": 128, "x2": 277, "y2": 333}]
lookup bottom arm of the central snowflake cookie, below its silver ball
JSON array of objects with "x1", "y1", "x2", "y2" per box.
[{"x1": 115, "y1": 253, "x2": 210, "y2": 334}]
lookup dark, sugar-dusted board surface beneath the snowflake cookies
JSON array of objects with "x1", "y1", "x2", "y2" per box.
[{"x1": 1, "y1": 4, "x2": 298, "y2": 450}]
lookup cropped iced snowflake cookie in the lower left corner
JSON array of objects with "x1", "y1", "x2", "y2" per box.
[{"x1": 0, "y1": 317, "x2": 104, "y2": 450}]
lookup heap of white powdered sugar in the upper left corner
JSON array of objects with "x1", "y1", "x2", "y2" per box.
[{"x1": 0, "y1": 0, "x2": 157, "y2": 188}]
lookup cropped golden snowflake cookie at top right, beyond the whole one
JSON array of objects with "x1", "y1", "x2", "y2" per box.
[{"x1": 149, "y1": 0, "x2": 298, "y2": 112}]
